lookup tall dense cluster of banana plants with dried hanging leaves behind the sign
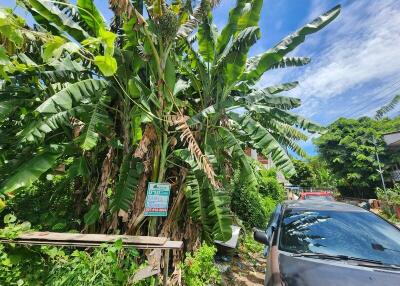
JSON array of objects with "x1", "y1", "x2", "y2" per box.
[{"x1": 0, "y1": 0, "x2": 340, "y2": 240}]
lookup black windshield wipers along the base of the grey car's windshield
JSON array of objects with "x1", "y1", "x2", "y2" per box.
[{"x1": 292, "y1": 252, "x2": 400, "y2": 270}]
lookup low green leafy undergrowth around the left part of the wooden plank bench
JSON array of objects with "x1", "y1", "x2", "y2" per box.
[{"x1": 0, "y1": 214, "x2": 154, "y2": 286}]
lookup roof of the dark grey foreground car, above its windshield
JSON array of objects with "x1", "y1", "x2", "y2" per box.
[{"x1": 283, "y1": 200, "x2": 368, "y2": 212}]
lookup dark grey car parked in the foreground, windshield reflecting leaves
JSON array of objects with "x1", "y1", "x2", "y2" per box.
[{"x1": 254, "y1": 200, "x2": 400, "y2": 286}]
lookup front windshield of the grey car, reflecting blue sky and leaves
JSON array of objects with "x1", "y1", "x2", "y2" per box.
[{"x1": 279, "y1": 210, "x2": 400, "y2": 265}]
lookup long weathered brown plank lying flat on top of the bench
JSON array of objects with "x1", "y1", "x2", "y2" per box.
[{"x1": 16, "y1": 232, "x2": 168, "y2": 245}]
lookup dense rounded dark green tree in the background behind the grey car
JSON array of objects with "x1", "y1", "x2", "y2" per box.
[{"x1": 314, "y1": 117, "x2": 400, "y2": 198}]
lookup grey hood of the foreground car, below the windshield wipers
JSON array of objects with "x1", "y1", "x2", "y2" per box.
[{"x1": 279, "y1": 253, "x2": 400, "y2": 286}]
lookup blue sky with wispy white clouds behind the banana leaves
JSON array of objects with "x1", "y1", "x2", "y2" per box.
[{"x1": 1, "y1": 0, "x2": 400, "y2": 153}]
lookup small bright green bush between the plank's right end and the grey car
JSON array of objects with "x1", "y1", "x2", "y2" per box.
[{"x1": 180, "y1": 244, "x2": 221, "y2": 286}]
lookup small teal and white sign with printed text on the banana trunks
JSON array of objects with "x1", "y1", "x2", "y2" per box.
[{"x1": 144, "y1": 183, "x2": 171, "y2": 216}]
